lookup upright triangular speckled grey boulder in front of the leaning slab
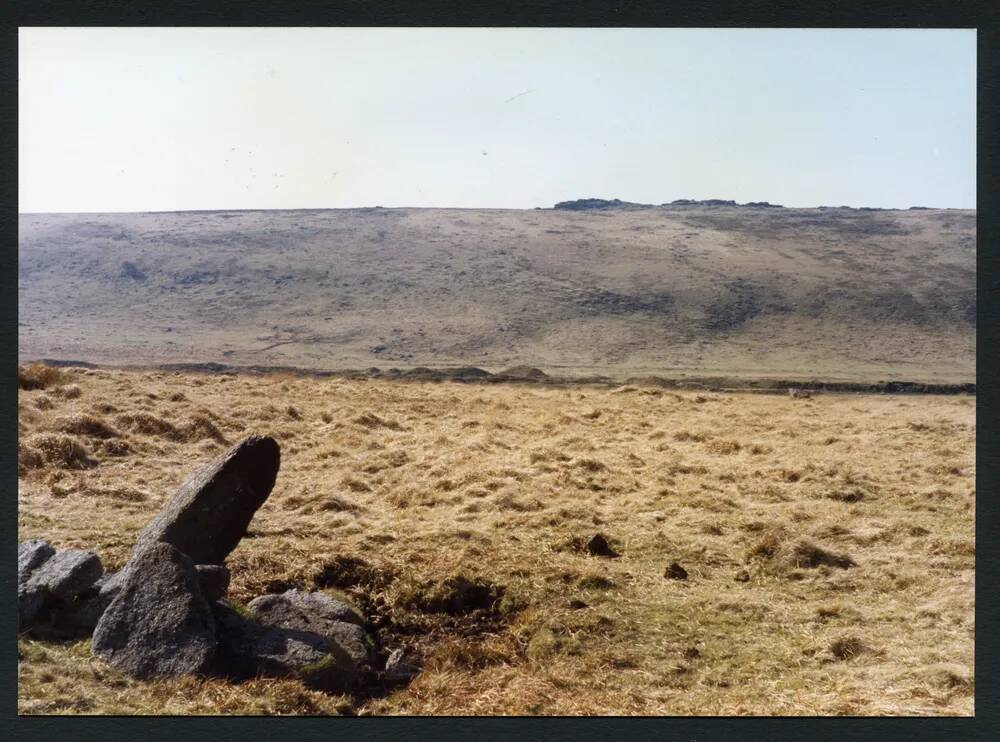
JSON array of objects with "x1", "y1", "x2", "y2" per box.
[{"x1": 91, "y1": 543, "x2": 217, "y2": 679}]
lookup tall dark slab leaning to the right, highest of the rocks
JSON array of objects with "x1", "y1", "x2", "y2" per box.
[{"x1": 133, "y1": 435, "x2": 281, "y2": 564}]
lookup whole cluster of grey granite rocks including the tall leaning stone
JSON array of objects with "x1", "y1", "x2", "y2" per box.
[{"x1": 17, "y1": 436, "x2": 418, "y2": 692}]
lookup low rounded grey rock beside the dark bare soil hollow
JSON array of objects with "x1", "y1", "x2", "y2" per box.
[{"x1": 247, "y1": 590, "x2": 372, "y2": 667}]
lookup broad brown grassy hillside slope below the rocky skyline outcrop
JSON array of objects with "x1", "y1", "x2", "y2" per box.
[{"x1": 18, "y1": 206, "x2": 976, "y2": 382}]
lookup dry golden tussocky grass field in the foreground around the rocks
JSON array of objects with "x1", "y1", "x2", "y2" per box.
[{"x1": 18, "y1": 369, "x2": 975, "y2": 715}]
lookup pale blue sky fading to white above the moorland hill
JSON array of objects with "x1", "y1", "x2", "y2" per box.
[{"x1": 19, "y1": 28, "x2": 976, "y2": 212}]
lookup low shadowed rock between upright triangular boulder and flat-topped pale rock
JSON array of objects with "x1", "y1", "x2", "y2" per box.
[{"x1": 214, "y1": 601, "x2": 359, "y2": 693}]
